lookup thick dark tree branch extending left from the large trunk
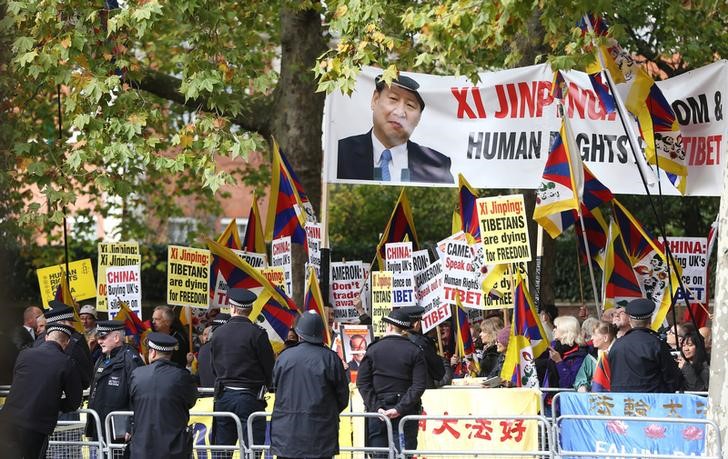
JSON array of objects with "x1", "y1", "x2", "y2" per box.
[{"x1": 127, "y1": 70, "x2": 274, "y2": 138}]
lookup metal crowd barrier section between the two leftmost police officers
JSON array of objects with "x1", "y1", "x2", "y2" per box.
[{"x1": 46, "y1": 409, "x2": 104, "y2": 459}]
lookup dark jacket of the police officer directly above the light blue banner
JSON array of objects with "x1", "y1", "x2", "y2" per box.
[{"x1": 608, "y1": 328, "x2": 683, "y2": 392}]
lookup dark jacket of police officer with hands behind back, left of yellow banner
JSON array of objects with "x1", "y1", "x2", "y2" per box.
[{"x1": 356, "y1": 335, "x2": 427, "y2": 415}]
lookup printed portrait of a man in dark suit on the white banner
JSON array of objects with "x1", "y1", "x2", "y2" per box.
[{"x1": 336, "y1": 75, "x2": 453, "y2": 183}]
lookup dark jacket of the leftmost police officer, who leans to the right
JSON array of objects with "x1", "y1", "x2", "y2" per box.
[{"x1": 0, "y1": 341, "x2": 83, "y2": 435}]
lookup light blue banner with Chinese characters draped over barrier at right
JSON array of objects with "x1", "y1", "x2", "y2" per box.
[{"x1": 559, "y1": 392, "x2": 707, "y2": 457}]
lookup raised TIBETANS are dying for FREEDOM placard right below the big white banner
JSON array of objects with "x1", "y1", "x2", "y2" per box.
[{"x1": 476, "y1": 194, "x2": 531, "y2": 264}]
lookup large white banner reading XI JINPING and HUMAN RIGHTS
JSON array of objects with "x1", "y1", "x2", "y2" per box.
[{"x1": 324, "y1": 60, "x2": 728, "y2": 196}]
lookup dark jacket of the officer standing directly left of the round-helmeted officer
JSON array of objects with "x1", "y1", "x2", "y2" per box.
[{"x1": 215, "y1": 316, "x2": 275, "y2": 392}]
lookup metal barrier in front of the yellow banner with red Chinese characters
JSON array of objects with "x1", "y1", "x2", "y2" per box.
[{"x1": 399, "y1": 415, "x2": 552, "y2": 459}]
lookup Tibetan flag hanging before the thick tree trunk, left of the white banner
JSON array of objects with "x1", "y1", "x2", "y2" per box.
[{"x1": 265, "y1": 140, "x2": 306, "y2": 246}]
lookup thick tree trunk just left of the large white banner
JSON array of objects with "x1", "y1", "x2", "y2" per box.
[{"x1": 273, "y1": 2, "x2": 326, "y2": 304}]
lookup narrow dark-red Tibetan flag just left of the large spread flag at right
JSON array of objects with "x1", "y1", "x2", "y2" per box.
[{"x1": 602, "y1": 217, "x2": 644, "y2": 309}]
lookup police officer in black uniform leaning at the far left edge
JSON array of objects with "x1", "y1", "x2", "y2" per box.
[{"x1": 0, "y1": 324, "x2": 83, "y2": 458}]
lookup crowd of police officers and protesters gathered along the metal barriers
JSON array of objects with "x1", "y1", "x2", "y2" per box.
[{"x1": 0, "y1": 289, "x2": 710, "y2": 458}]
